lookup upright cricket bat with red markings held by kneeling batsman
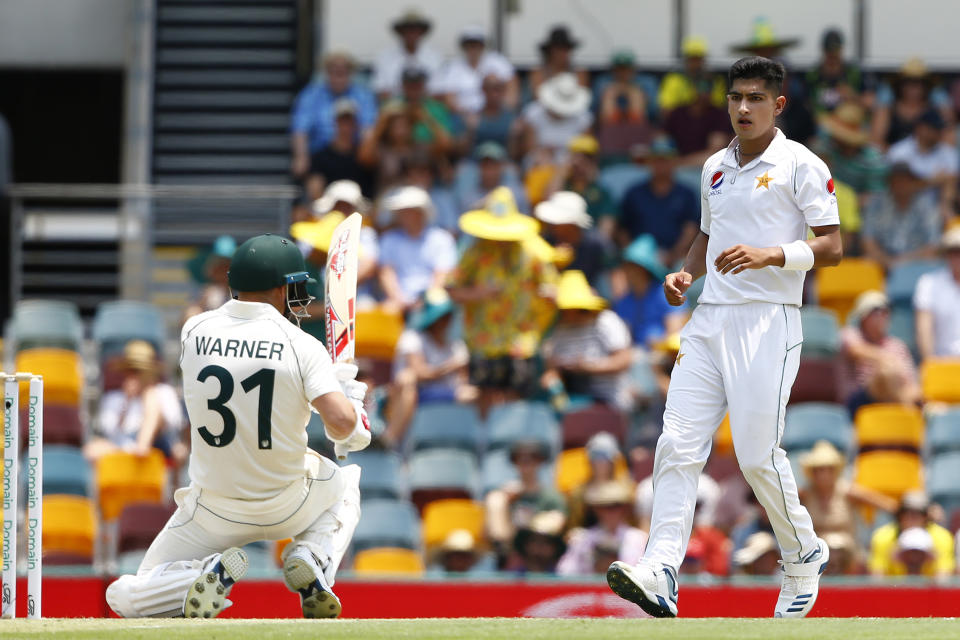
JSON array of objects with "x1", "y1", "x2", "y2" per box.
[{"x1": 323, "y1": 212, "x2": 362, "y2": 460}]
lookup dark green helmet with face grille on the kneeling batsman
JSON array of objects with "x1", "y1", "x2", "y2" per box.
[{"x1": 227, "y1": 233, "x2": 316, "y2": 319}]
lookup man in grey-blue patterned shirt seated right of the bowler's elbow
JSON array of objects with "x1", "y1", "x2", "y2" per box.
[{"x1": 861, "y1": 162, "x2": 943, "y2": 269}]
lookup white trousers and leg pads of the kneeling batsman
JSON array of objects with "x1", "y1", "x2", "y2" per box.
[{"x1": 107, "y1": 451, "x2": 360, "y2": 618}]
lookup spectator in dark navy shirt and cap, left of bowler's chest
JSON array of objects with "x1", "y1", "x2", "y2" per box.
[{"x1": 619, "y1": 136, "x2": 700, "y2": 265}]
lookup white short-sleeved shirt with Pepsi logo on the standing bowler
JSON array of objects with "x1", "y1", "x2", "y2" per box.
[{"x1": 699, "y1": 129, "x2": 840, "y2": 305}]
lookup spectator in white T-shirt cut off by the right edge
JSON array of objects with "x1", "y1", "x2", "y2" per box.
[{"x1": 913, "y1": 227, "x2": 960, "y2": 360}]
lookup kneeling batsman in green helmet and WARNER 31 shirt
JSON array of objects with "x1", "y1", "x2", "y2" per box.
[{"x1": 107, "y1": 235, "x2": 370, "y2": 618}]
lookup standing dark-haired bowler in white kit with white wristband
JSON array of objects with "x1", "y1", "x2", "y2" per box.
[{"x1": 607, "y1": 57, "x2": 843, "y2": 618}]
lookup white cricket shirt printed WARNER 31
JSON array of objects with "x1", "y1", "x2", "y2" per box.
[{"x1": 180, "y1": 300, "x2": 340, "y2": 500}]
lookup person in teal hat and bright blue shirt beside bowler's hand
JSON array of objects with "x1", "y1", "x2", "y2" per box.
[{"x1": 613, "y1": 234, "x2": 687, "y2": 347}]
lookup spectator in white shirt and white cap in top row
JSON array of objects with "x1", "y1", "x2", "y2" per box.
[{"x1": 438, "y1": 25, "x2": 520, "y2": 115}]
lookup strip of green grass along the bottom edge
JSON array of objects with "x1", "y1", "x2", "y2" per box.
[{"x1": 0, "y1": 618, "x2": 960, "y2": 640}]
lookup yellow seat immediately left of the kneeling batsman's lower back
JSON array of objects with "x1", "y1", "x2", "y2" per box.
[{"x1": 96, "y1": 449, "x2": 167, "y2": 522}]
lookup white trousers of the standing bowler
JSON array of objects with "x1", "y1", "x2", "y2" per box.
[{"x1": 645, "y1": 302, "x2": 817, "y2": 568}]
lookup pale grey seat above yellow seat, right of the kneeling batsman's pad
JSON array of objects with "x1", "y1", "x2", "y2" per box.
[{"x1": 409, "y1": 449, "x2": 480, "y2": 513}]
